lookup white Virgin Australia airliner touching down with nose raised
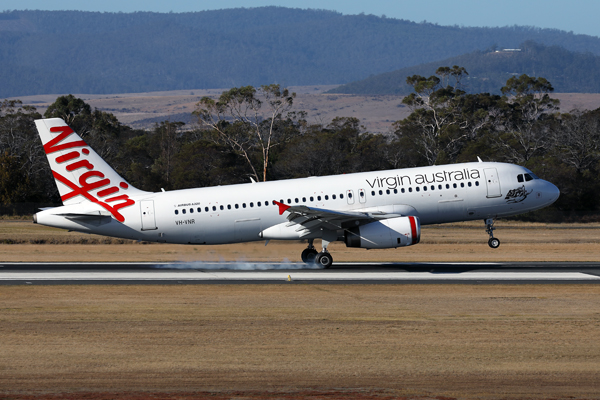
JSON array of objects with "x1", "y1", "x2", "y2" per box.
[{"x1": 33, "y1": 118, "x2": 559, "y2": 268}]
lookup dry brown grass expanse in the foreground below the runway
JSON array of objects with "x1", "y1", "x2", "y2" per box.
[{"x1": 0, "y1": 284, "x2": 600, "y2": 399}]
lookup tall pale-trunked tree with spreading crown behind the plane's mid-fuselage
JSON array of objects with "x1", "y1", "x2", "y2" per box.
[{"x1": 194, "y1": 84, "x2": 304, "y2": 181}]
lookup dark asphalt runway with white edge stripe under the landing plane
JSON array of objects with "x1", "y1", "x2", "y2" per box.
[{"x1": 0, "y1": 262, "x2": 600, "y2": 285}]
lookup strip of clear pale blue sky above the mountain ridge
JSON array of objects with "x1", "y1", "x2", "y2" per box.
[{"x1": 0, "y1": 0, "x2": 600, "y2": 36}]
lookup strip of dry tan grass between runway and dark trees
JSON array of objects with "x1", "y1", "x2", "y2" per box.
[{"x1": 0, "y1": 221, "x2": 600, "y2": 262}]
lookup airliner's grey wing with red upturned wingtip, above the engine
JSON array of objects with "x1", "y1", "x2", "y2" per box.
[{"x1": 274, "y1": 201, "x2": 400, "y2": 237}]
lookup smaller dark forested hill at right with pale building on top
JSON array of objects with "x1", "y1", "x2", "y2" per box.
[{"x1": 330, "y1": 41, "x2": 600, "y2": 95}]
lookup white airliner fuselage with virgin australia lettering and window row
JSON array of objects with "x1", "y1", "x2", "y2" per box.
[{"x1": 36, "y1": 162, "x2": 559, "y2": 244}]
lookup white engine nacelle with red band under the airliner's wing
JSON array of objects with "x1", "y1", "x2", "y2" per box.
[{"x1": 344, "y1": 216, "x2": 421, "y2": 249}]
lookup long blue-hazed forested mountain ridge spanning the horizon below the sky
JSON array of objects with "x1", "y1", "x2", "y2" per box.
[{"x1": 0, "y1": 7, "x2": 600, "y2": 98}]
